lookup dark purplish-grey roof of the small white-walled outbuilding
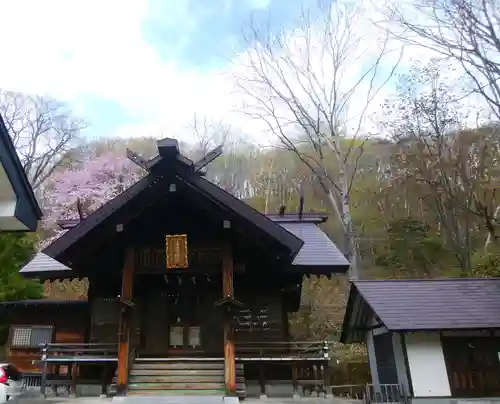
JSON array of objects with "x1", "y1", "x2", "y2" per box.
[{"x1": 342, "y1": 278, "x2": 500, "y2": 342}]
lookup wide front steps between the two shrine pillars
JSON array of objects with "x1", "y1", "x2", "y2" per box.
[{"x1": 127, "y1": 358, "x2": 246, "y2": 398}]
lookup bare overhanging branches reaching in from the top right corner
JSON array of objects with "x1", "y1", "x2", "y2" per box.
[{"x1": 385, "y1": 0, "x2": 500, "y2": 119}]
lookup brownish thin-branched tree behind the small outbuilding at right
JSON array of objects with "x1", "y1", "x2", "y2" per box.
[{"x1": 380, "y1": 62, "x2": 500, "y2": 274}]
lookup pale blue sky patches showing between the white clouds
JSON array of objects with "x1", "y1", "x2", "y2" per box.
[{"x1": 81, "y1": 0, "x2": 312, "y2": 137}]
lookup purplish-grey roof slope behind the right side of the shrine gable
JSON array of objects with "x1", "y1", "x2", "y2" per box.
[{"x1": 280, "y1": 221, "x2": 349, "y2": 270}]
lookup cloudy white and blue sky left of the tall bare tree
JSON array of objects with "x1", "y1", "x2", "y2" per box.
[{"x1": 0, "y1": 0, "x2": 450, "y2": 144}]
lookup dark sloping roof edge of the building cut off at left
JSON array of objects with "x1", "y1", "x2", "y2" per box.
[{"x1": 0, "y1": 115, "x2": 42, "y2": 231}]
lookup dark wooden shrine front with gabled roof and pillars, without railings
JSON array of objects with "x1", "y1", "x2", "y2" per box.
[{"x1": 14, "y1": 139, "x2": 348, "y2": 392}]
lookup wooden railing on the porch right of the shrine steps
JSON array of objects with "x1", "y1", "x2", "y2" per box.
[{"x1": 236, "y1": 341, "x2": 332, "y2": 361}]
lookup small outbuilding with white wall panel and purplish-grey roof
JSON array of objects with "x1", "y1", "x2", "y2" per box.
[{"x1": 341, "y1": 278, "x2": 500, "y2": 402}]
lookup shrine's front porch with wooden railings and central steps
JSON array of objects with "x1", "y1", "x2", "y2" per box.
[{"x1": 35, "y1": 341, "x2": 336, "y2": 398}]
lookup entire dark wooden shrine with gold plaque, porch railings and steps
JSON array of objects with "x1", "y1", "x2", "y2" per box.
[{"x1": 8, "y1": 139, "x2": 349, "y2": 397}]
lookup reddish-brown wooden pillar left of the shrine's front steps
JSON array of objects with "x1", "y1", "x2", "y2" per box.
[{"x1": 116, "y1": 248, "x2": 134, "y2": 395}]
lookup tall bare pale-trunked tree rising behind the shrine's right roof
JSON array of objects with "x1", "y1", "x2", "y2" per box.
[{"x1": 235, "y1": 2, "x2": 402, "y2": 278}]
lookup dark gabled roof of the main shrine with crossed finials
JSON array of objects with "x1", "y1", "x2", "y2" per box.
[{"x1": 25, "y1": 139, "x2": 349, "y2": 275}]
